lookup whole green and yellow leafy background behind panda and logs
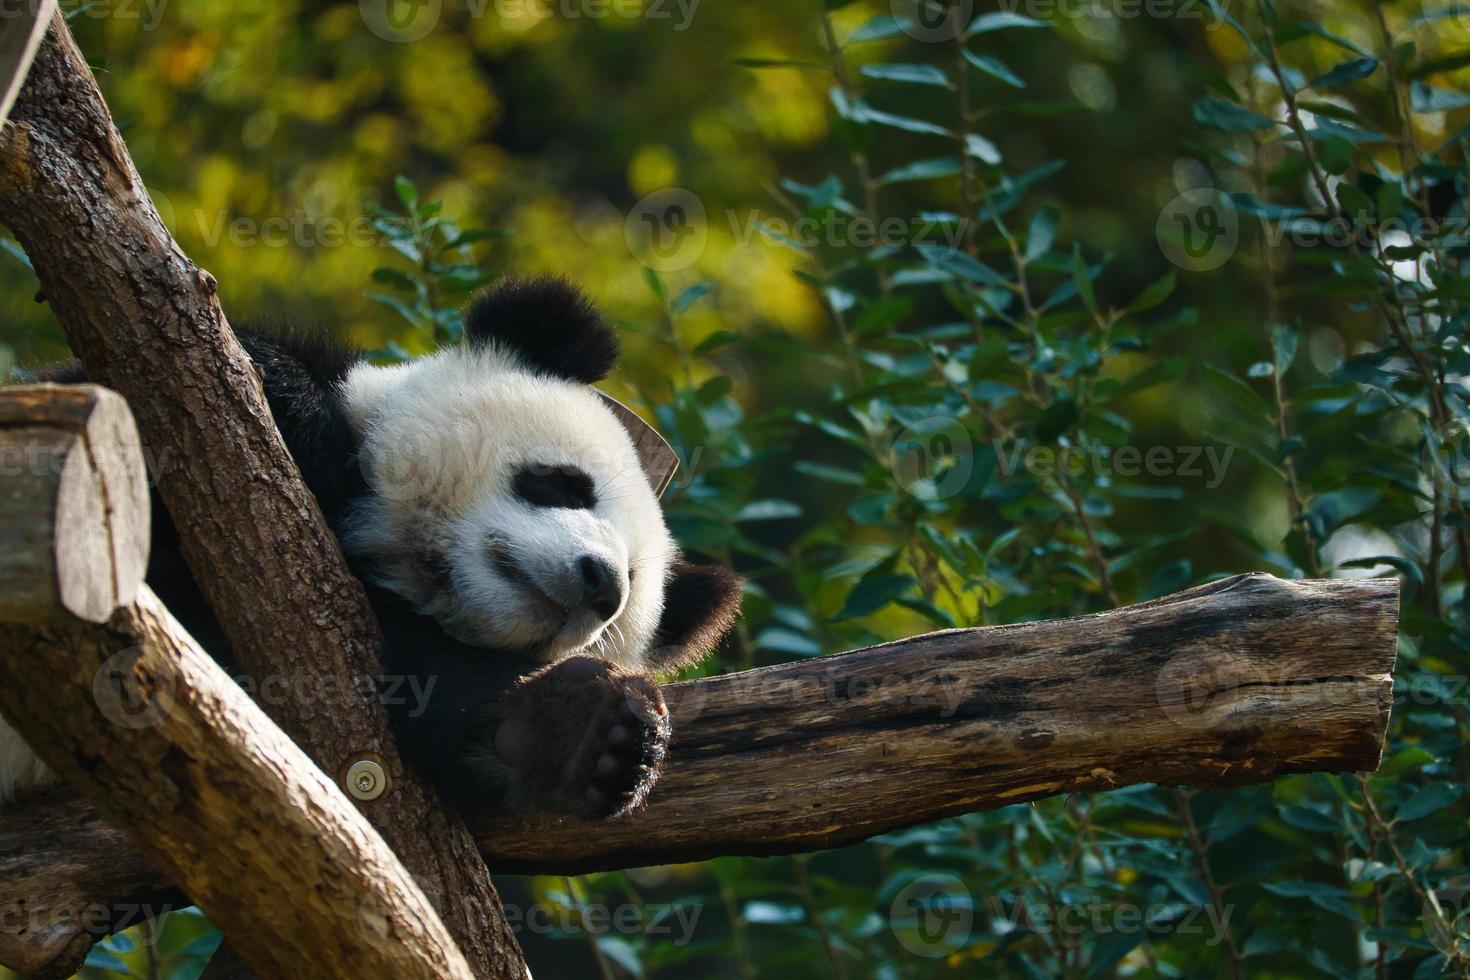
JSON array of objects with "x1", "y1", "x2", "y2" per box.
[{"x1": 0, "y1": 0, "x2": 1470, "y2": 977}]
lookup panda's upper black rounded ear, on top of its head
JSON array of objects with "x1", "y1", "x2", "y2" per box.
[{"x1": 465, "y1": 276, "x2": 617, "y2": 385}]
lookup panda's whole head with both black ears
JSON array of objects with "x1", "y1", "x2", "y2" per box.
[{"x1": 343, "y1": 279, "x2": 738, "y2": 667}]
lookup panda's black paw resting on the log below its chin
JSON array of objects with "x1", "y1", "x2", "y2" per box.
[{"x1": 494, "y1": 657, "x2": 672, "y2": 818}]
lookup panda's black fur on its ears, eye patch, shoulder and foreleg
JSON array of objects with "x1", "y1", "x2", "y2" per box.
[{"x1": 34, "y1": 295, "x2": 734, "y2": 817}]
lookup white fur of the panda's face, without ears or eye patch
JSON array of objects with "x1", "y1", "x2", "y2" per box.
[{"x1": 343, "y1": 345, "x2": 675, "y2": 667}]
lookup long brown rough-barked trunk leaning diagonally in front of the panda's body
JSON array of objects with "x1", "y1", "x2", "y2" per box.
[{"x1": 0, "y1": 15, "x2": 525, "y2": 977}]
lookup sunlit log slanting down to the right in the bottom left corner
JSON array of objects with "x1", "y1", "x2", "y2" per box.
[{"x1": 0, "y1": 586, "x2": 472, "y2": 979}]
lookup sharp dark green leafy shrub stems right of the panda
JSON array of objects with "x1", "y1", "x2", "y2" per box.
[{"x1": 520, "y1": 3, "x2": 1470, "y2": 977}]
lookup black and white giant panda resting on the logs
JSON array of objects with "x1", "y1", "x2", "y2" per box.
[{"x1": 0, "y1": 278, "x2": 739, "y2": 818}]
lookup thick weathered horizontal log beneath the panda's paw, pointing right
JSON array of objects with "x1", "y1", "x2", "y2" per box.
[{"x1": 0, "y1": 574, "x2": 1398, "y2": 961}]
